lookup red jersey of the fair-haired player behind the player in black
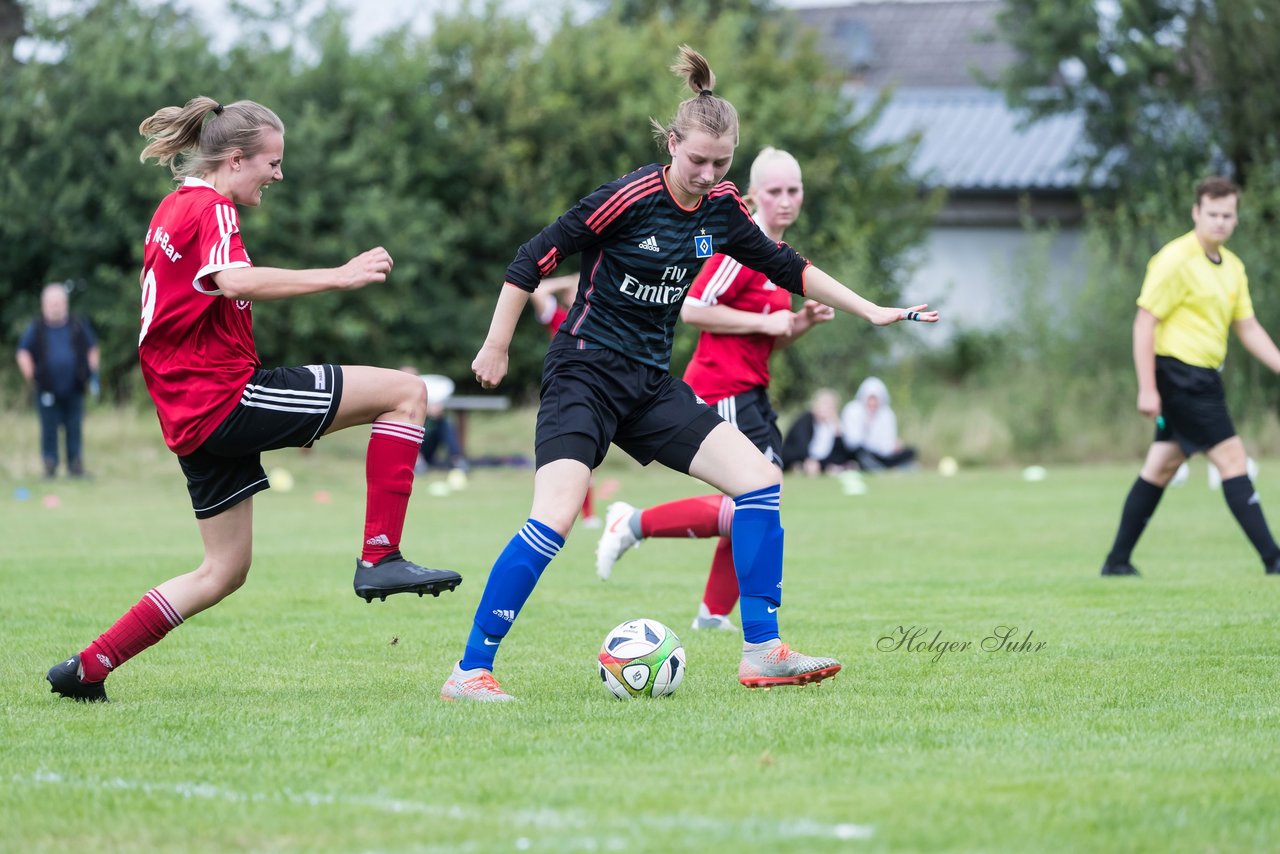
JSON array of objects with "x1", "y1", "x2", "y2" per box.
[{"x1": 685, "y1": 255, "x2": 791, "y2": 403}]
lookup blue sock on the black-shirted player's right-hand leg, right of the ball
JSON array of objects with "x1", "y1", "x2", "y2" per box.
[{"x1": 732, "y1": 484, "x2": 782, "y2": 644}]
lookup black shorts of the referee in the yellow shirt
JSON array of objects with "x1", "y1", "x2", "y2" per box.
[{"x1": 1156, "y1": 356, "x2": 1235, "y2": 456}]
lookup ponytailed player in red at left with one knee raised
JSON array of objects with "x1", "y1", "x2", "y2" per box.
[{"x1": 47, "y1": 97, "x2": 462, "y2": 702}]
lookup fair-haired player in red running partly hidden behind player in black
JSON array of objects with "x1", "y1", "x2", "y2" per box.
[{"x1": 595, "y1": 147, "x2": 836, "y2": 630}]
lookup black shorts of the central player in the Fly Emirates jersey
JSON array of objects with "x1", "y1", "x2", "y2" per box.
[{"x1": 534, "y1": 333, "x2": 723, "y2": 474}]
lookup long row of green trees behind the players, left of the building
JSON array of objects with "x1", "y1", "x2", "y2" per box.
[{"x1": 0, "y1": 0, "x2": 928, "y2": 407}]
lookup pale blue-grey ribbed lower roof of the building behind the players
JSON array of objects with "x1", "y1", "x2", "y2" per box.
[{"x1": 859, "y1": 87, "x2": 1084, "y2": 192}]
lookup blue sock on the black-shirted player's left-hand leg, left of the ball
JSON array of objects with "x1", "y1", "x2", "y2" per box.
[{"x1": 460, "y1": 519, "x2": 564, "y2": 671}]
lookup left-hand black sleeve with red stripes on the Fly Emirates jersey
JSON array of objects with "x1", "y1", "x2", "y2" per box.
[{"x1": 507, "y1": 165, "x2": 660, "y2": 293}]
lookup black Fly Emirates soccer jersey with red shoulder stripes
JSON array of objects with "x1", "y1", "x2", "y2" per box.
[{"x1": 507, "y1": 164, "x2": 809, "y2": 370}]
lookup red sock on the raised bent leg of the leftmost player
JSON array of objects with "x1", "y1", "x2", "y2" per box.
[{"x1": 360, "y1": 421, "x2": 424, "y2": 563}]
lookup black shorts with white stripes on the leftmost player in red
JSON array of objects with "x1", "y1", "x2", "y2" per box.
[{"x1": 178, "y1": 365, "x2": 342, "y2": 519}]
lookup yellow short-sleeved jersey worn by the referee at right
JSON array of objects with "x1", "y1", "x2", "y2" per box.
[{"x1": 1138, "y1": 232, "x2": 1253, "y2": 367}]
